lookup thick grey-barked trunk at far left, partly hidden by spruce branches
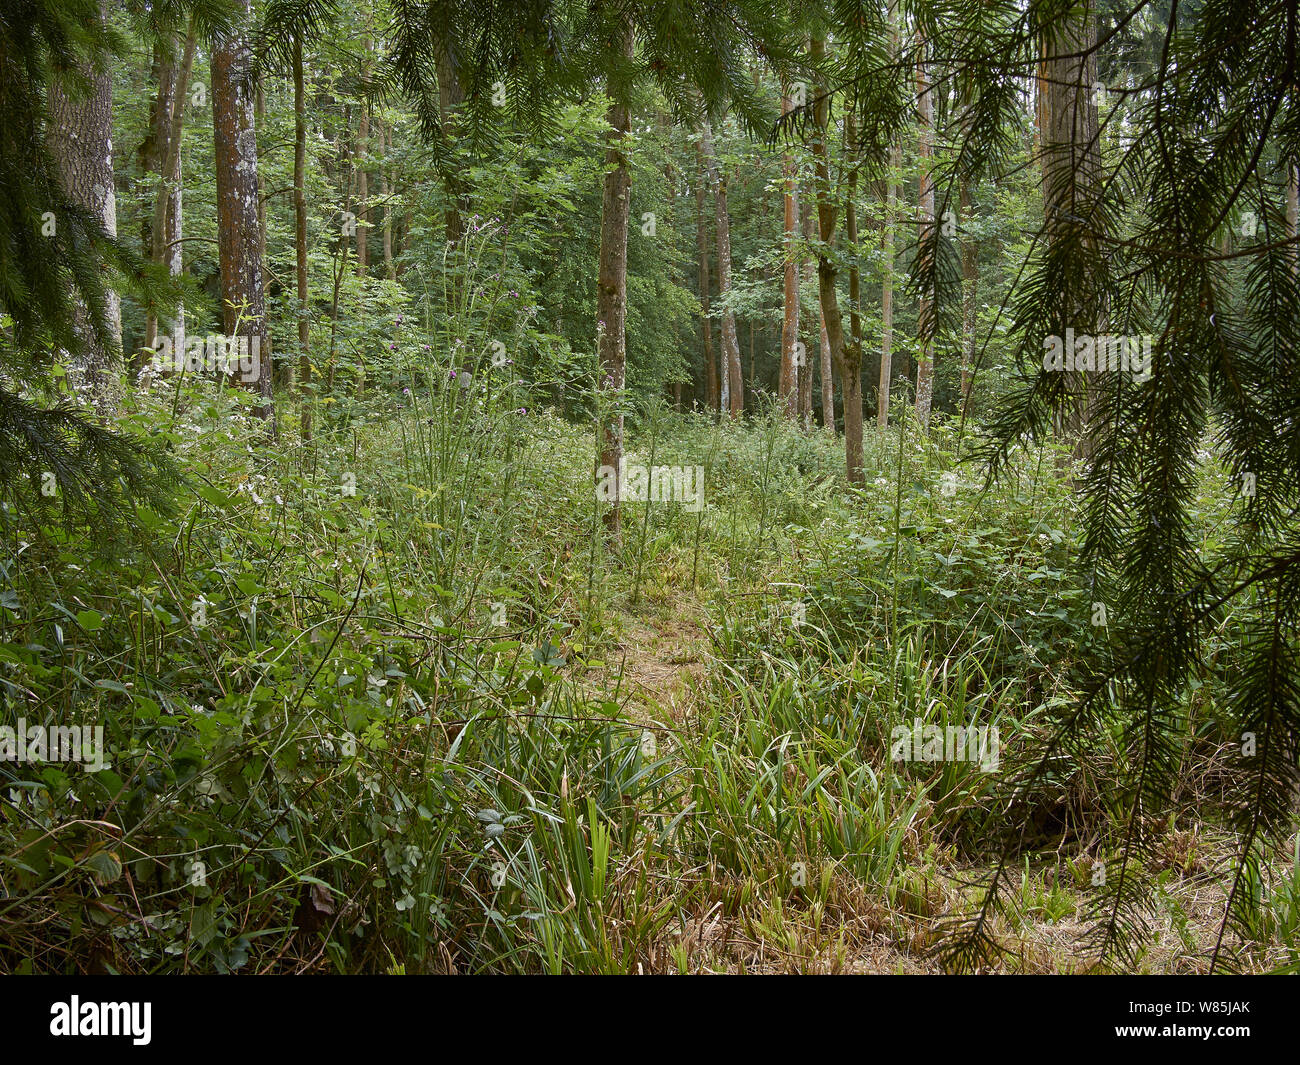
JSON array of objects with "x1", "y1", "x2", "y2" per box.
[{"x1": 47, "y1": 0, "x2": 122, "y2": 415}]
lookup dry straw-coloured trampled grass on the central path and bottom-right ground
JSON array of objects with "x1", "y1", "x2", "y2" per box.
[{"x1": 584, "y1": 596, "x2": 1258, "y2": 975}]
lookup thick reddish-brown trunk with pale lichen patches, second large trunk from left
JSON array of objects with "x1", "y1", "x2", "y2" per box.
[{"x1": 212, "y1": 0, "x2": 274, "y2": 423}]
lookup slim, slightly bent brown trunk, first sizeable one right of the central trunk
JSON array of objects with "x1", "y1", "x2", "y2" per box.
[{"x1": 809, "y1": 36, "x2": 863, "y2": 484}]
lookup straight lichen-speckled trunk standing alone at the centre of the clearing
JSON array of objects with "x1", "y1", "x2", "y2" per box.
[{"x1": 595, "y1": 20, "x2": 634, "y2": 538}]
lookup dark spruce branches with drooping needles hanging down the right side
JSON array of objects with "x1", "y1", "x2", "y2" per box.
[{"x1": 811, "y1": 0, "x2": 1300, "y2": 970}]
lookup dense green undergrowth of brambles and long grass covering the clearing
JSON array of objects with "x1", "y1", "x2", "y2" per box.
[{"x1": 0, "y1": 372, "x2": 1300, "y2": 973}]
